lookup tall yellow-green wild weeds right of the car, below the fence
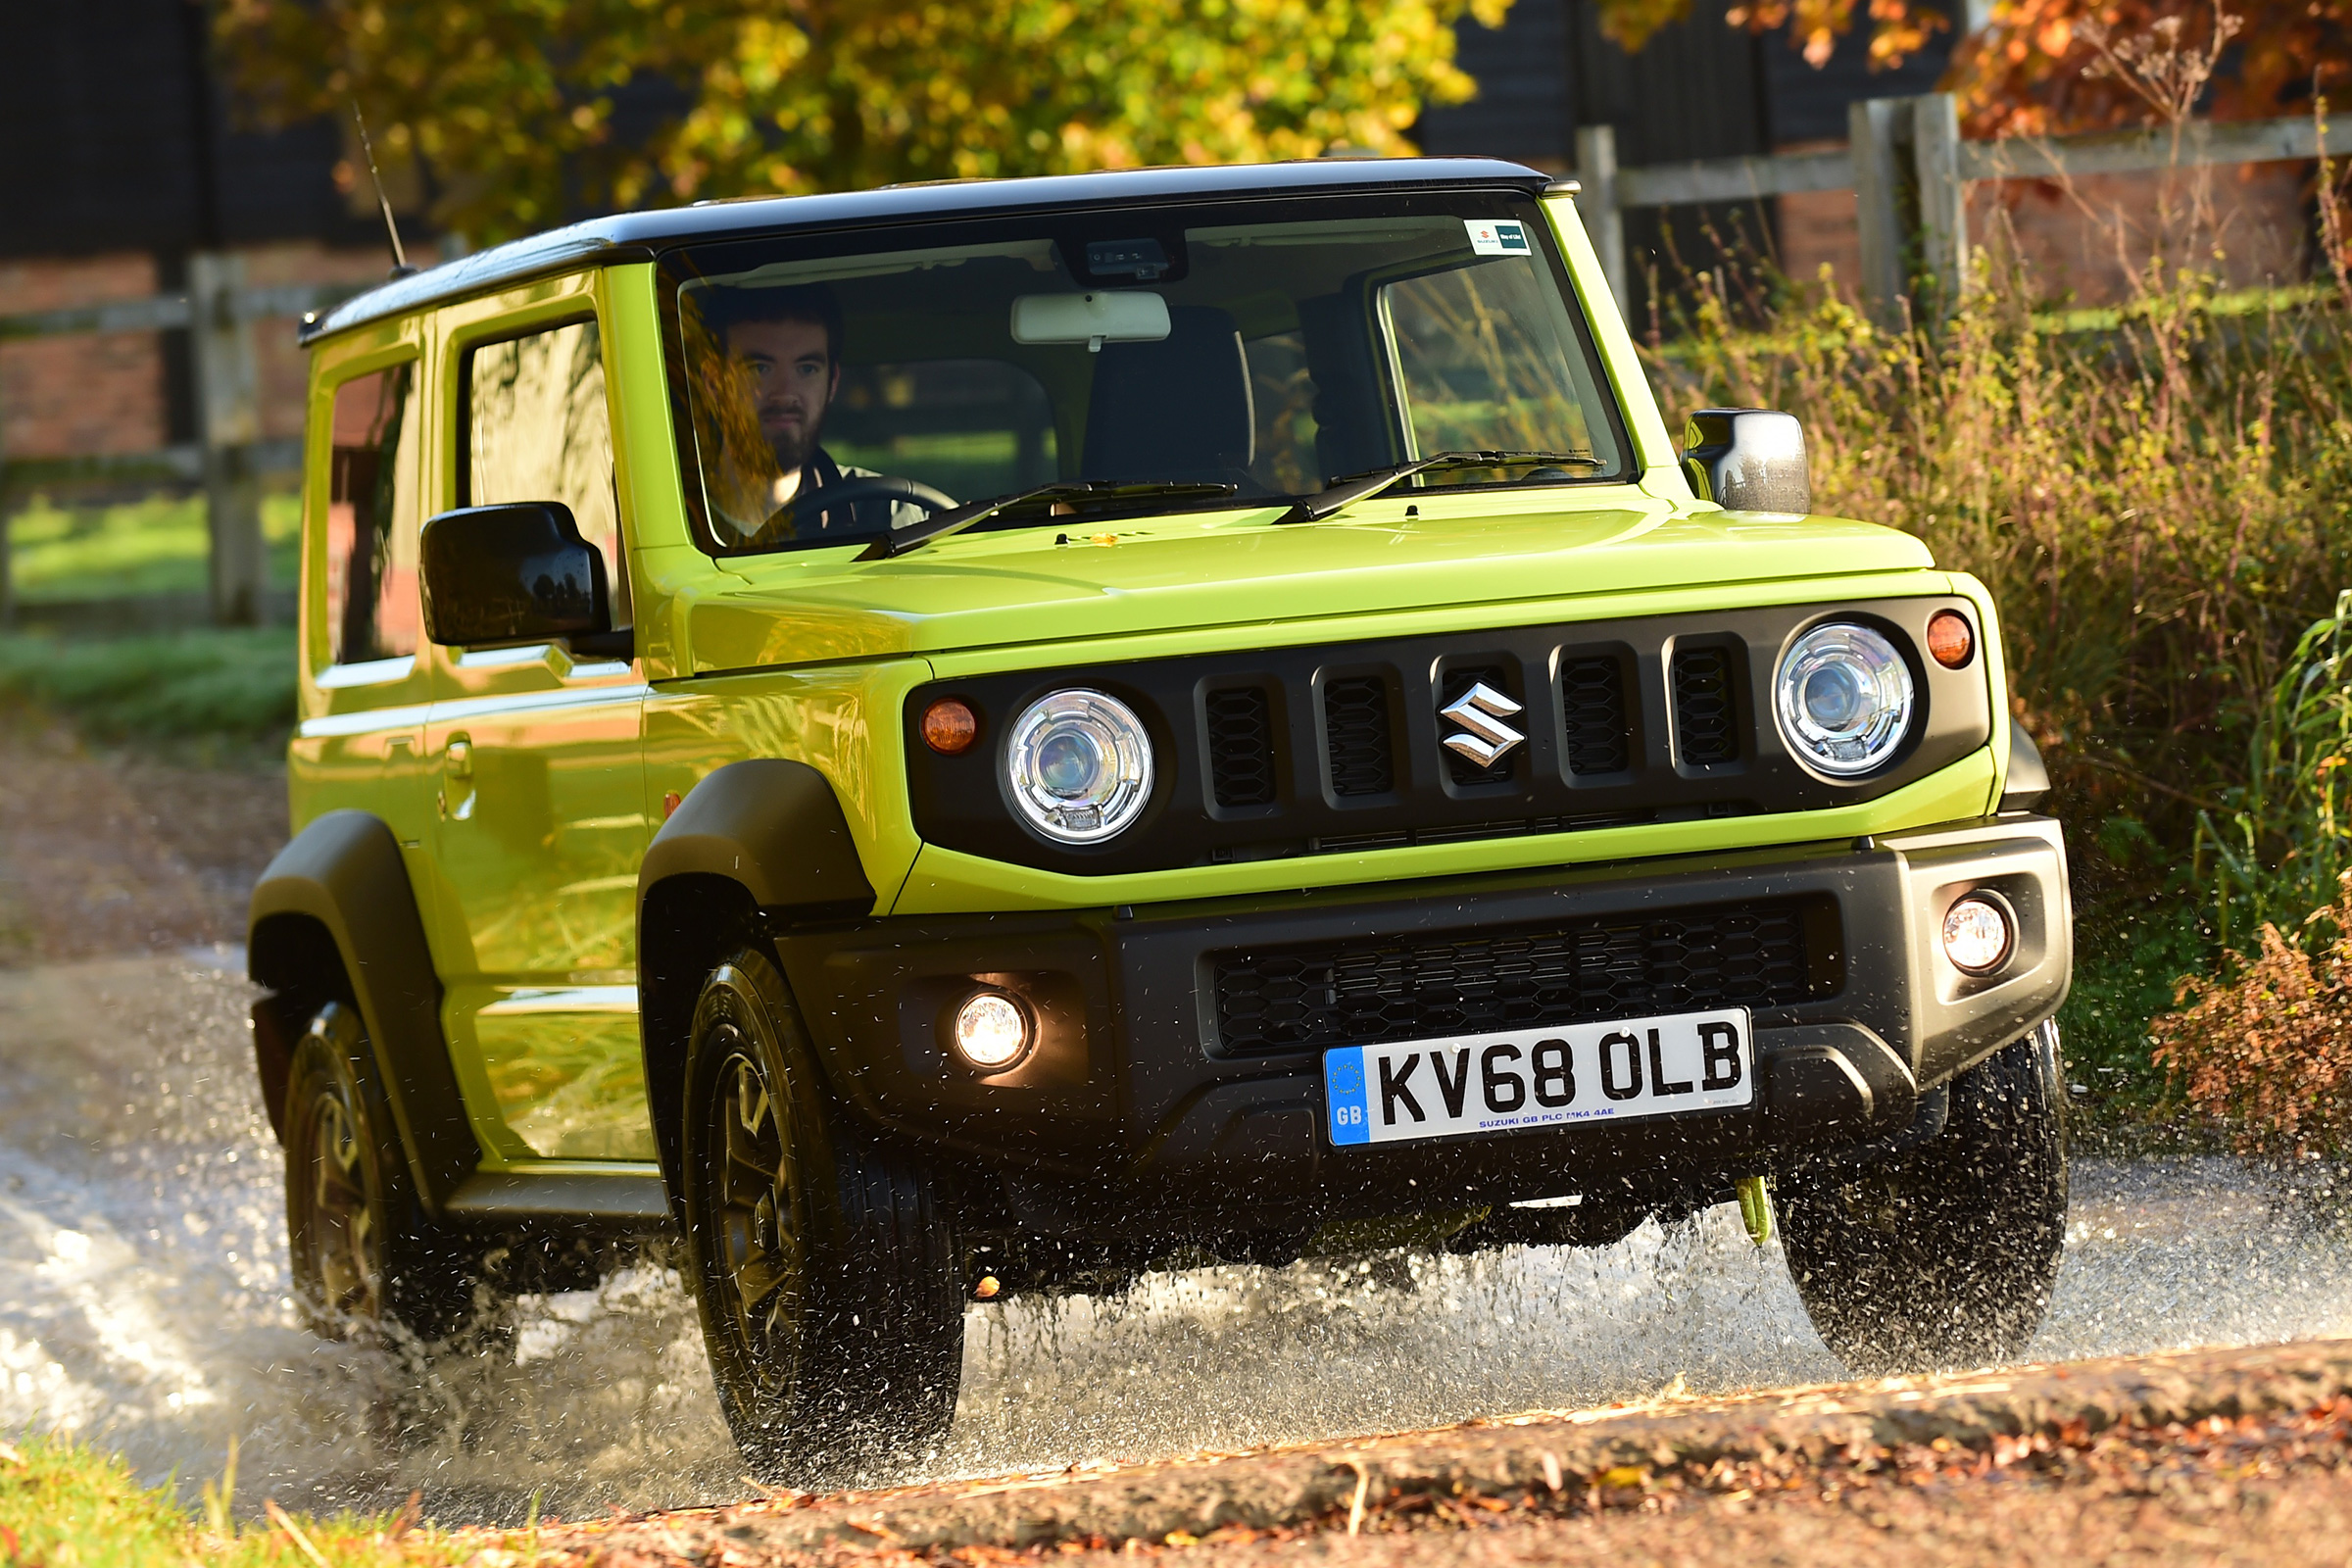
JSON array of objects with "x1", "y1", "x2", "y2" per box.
[{"x1": 1648, "y1": 242, "x2": 2352, "y2": 1131}]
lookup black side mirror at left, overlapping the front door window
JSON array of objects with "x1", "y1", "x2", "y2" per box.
[{"x1": 416, "y1": 501, "x2": 612, "y2": 649}]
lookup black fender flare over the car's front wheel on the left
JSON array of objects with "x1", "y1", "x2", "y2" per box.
[{"x1": 637, "y1": 757, "x2": 875, "y2": 1201}]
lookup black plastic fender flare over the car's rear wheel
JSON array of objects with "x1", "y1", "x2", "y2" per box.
[{"x1": 245, "y1": 811, "x2": 482, "y2": 1218}]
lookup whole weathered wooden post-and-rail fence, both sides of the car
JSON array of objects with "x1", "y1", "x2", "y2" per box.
[{"x1": 0, "y1": 92, "x2": 2352, "y2": 625}]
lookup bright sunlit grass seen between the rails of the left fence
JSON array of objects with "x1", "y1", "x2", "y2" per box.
[{"x1": 7, "y1": 494, "x2": 301, "y2": 604}]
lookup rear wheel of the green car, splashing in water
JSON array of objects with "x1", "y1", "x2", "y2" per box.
[{"x1": 284, "y1": 1002, "x2": 472, "y2": 1340}]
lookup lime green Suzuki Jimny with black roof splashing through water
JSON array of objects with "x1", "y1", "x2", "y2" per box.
[{"x1": 249, "y1": 160, "x2": 2072, "y2": 1476}]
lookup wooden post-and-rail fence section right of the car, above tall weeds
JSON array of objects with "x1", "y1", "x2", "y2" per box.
[{"x1": 1576, "y1": 92, "x2": 2352, "y2": 324}]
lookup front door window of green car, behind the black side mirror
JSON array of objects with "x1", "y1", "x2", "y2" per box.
[{"x1": 461, "y1": 322, "x2": 630, "y2": 625}]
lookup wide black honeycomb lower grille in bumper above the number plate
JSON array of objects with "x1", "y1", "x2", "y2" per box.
[{"x1": 1216, "y1": 898, "x2": 1839, "y2": 1054}]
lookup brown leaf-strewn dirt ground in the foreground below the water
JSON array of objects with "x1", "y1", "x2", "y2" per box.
[{"x1": 519, "y1": 1340, "x2": 2352, "y2": 1568}]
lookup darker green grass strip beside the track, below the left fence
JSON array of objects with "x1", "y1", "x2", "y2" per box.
[{"x1": 0, "y1": 627, "x2": 294, "y2": 745}]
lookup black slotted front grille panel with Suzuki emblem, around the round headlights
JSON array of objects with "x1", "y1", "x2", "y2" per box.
[{"x1": 904, "y1": 595, "x2": 1992, "y2": 886}]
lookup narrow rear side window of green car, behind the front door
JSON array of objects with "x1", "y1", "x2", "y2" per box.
[{"x1": 327, "y1": 365, "x2": 423, "y2": 665}]
